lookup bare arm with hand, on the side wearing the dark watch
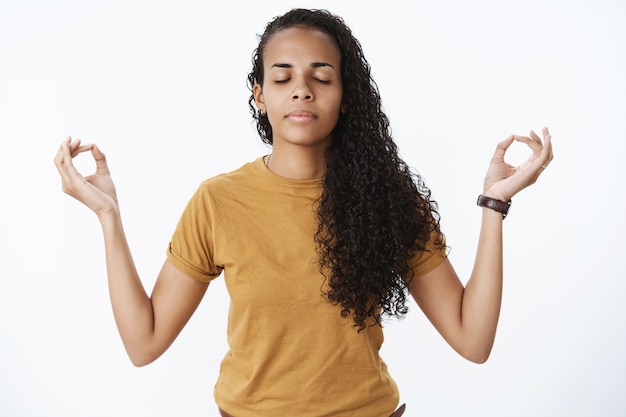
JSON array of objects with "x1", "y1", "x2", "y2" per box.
[{"x1": 409, "y1": 129, "x2": 552, "y2": 363}]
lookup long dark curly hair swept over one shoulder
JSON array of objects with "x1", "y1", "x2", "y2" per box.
[{"x1": 248, "y1": 9, "x2": 445, "y2": 331}]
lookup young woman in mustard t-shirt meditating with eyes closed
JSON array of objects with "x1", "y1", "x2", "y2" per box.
[{"x1": 55, "y1": 9, "x2": 552, "y2": 417}]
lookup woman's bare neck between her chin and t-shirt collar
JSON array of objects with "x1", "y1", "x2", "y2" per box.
[{"x1": 267, "y1": 146, "x2": 326, "y2": 180}]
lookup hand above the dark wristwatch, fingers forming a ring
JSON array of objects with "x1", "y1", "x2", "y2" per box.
[{"x1": 483, "y1": 127, "x2": 552, "y2": 201}]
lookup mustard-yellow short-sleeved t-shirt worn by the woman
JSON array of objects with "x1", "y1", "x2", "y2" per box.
[{"x1": 168, "y1": 158, "x2": 445, "y2": 417}]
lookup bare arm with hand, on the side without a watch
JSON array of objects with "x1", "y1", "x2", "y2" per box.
[{"x1": 55, "y1": 138, "x2": 208, "y2": 366}]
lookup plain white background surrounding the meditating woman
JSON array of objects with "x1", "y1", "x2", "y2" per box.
[{"x1": 0, "y1": 0, "x2": 626, "y2": 417}]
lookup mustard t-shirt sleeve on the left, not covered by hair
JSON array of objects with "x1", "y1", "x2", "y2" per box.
[{"x1": 167, "y1": 183, "x2": 222, "y2": 282}]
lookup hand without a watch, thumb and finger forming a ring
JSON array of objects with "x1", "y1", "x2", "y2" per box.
[{"x1": 54, "y1": 136, "x2": 119, "y2": 218}]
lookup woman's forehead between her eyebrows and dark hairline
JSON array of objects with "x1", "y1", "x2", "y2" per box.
[{"x1": 263, "y1": 26, "x2": 341, "y2": 67}]
